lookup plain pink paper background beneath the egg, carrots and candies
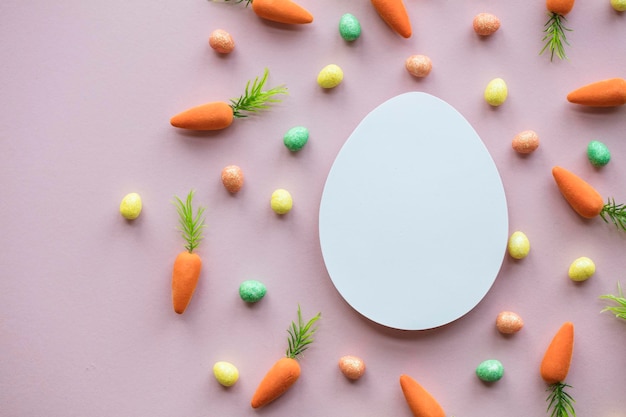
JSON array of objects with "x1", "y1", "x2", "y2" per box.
[{"x1": 0, "y1": 0, "x2": 626, "y2": 417}]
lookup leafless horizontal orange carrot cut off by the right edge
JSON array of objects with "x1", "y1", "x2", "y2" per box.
[{"x1": 567, "y1": 78, "x2": 626, "y2": 107}]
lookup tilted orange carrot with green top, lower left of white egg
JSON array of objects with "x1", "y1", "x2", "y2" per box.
[{"x1": 250, "y1": 306, "x2": 321, "y2": 408}]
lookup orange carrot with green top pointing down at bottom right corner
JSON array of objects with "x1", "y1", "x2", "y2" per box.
[{"x1": 539, "y1": 321, "x2": 576, "y2": 417}]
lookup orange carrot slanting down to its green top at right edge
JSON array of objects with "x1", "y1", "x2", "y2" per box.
[{"x1": 552, "y1": 166, "x2": 626, "y2": 231}]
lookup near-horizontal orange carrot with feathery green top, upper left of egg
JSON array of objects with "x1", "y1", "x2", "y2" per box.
[{"x1": 170, "y1": 68, "x2": 287, "y2": 130}]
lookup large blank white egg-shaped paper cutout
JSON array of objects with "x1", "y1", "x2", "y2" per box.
[{"x1": 319, "y1": 92, "x2": 508, "y2": 330}]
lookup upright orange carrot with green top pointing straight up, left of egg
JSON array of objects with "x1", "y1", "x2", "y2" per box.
[{"x1": 172, "y1": 190, "x2": 204, "y2": 314}]
